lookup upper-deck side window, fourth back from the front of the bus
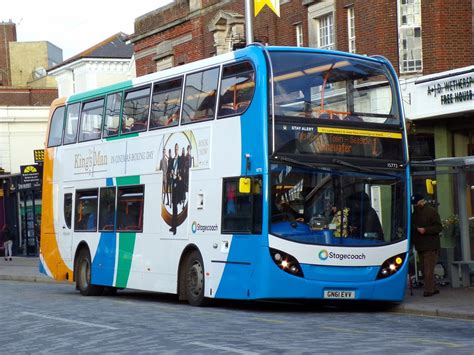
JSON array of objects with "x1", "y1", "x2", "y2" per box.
[{"x1": 122, "y1": 87, "x2": 150, "y2": 133}]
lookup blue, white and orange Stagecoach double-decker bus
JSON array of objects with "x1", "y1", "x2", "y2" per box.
[{"x1": 40, "y1": 44, "x2": 410, "y2": 305}]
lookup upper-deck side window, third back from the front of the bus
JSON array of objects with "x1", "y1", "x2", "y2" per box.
[{"x1": 150, "y1": 78, "x2": 183, "y2": 129}]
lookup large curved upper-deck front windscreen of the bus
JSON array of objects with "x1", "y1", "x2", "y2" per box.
[{"x1": 271, "y1": 52, "x2": 400, "y2": 125}]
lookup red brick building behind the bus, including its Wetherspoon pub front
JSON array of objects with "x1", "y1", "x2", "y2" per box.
[{"x1": 130, "y1": 0, "x2": 474, "y2": 276}]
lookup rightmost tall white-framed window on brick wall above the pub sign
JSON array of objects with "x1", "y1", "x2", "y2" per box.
[{"x1": 398, "y1": 0, "x2": 423, "y2": 73}]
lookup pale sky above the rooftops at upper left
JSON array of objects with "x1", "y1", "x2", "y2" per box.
[{"x1": 0, "y1": 0, "x2": 172, "y2": 60}]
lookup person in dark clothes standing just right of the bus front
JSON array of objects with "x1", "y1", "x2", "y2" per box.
[{"x1": 411, "y1": 194, "x2": 443, "y2": 297}]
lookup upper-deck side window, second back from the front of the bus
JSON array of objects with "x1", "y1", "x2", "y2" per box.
[{"x1": 182, "y1": 68, "x2": 219, "y2": 123}]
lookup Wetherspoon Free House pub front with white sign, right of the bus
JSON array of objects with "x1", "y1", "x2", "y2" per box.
[{"x1": 401, "y1": 66, "x2": 474, "y2": 286}]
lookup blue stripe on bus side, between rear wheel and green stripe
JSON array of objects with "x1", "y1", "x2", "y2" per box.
[{"x1": 92, "y1": 178, "x2": 117, "y2": 286}]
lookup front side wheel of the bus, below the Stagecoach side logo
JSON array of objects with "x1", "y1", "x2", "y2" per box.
[{"x1": 186, "y1": 250, "x2": 207, "y2": 306}]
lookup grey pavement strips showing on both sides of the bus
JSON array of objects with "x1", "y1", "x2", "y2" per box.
[{"x1": 0, "y1": 257, "x2": 474, "y2": 320}]
